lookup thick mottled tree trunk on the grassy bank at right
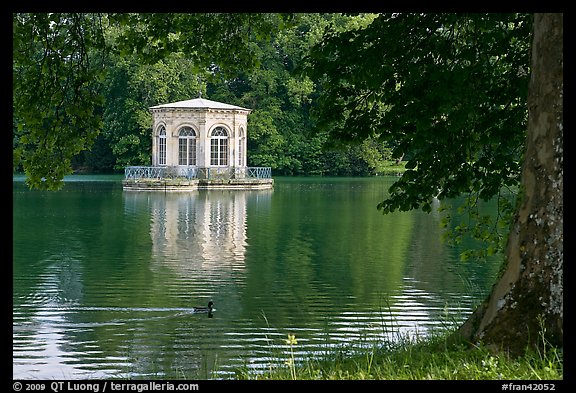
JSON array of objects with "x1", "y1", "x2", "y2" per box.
[{"x1": 457, "y1": 14, "x2": 564, "y2": 355}]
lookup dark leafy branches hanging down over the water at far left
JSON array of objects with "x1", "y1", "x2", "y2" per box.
[{"x1": 12, "y1": 13, "x2": 104, "y2": 189}]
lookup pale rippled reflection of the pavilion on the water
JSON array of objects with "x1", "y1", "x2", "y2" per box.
[{"x1": 125, "y1": 190, "x2": 272, "y2": 274}]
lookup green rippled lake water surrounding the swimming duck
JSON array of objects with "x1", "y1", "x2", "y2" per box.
[{"x1": 13, "y1": 176, "x2": 499, "y2": 379}]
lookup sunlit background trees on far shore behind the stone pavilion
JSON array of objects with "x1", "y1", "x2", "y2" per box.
[{"x1": 17, "y1": 14, "x2": 391, "y2": 175}]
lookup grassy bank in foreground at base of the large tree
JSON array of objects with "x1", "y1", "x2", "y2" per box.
[{"x1": 236, "y1": 335, "x2": 563, "y2": 380}]
